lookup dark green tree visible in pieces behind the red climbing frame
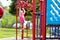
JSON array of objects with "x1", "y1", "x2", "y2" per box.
[{"x1": 9, "y1": 0, "x2": 39, "y2": 16}]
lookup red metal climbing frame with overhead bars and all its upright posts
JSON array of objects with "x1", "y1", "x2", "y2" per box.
[{"x1": 16, "y1": 0, "x2": 46, "y2": 40}]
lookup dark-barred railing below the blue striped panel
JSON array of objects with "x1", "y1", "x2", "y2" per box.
[{"x1": 46, "y1": 25, "x2": 60, "y2": 39}]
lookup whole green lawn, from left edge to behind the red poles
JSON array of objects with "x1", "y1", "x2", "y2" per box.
[{"x1": 0, "y1": 28, "x2": 32, "y2": 39}]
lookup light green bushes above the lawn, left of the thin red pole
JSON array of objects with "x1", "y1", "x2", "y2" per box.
[{"x1": 2, "y1": 11, "x2": 16, "y2": 28}]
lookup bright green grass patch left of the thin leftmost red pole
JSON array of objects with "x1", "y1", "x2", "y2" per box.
[{"x1": 0, "y1": 28, "x2": 16, "y2": 38}]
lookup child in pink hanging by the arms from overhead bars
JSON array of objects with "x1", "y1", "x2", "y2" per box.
[{"x1": 19, "y1": 8, "x2": 25, "y2": 39}]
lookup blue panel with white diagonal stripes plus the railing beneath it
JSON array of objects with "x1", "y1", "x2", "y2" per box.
[{"x1": 46, "y1": 0, "x2": 60, "y2": 40}]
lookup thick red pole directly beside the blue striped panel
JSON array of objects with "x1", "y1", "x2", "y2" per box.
[{"x1": 40, "y1": 0, "x2": 47, "y2": 40}]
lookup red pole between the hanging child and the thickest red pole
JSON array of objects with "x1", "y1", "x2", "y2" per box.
[{"x1": 32, "y1": 0, "x2": 36, "y2": 40}]
